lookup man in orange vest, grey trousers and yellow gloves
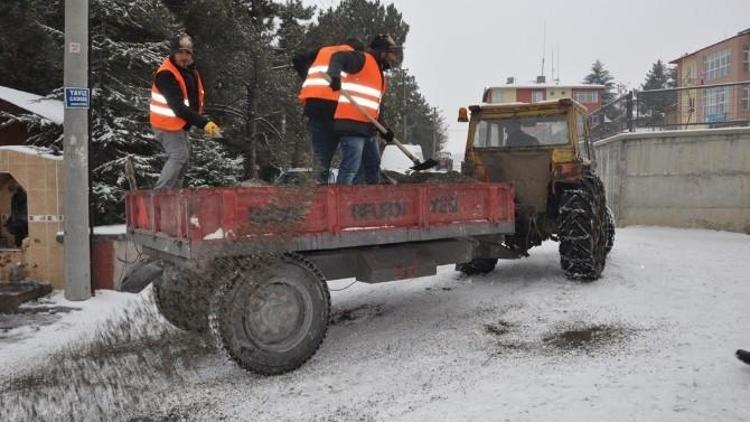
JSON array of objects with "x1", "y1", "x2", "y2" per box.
[{"x1": 149, "y1": 34, "x2": 221, "y2": 189}]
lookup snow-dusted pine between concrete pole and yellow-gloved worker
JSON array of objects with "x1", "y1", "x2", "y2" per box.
[{"x1": 25, "y1": 0, "x2": 244, "y2": 224}]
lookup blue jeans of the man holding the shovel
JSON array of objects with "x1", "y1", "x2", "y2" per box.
[{"x1": 336, "y1": 136, "x2": 380, "y2": 185}]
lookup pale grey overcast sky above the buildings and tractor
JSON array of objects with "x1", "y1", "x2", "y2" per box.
[{"x1": 307, "y1": 0, "x2": 750, "y2": 152}]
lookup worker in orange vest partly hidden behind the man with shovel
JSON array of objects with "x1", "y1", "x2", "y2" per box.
[{"x1": 292, "y1": 38, "x2": 364, "y2": 185}]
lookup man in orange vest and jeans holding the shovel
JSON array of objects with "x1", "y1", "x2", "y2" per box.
[{"x1": 328, "y1": 34, "x2": 401, "y2": 185}]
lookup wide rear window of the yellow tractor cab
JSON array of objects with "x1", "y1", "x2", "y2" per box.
[{"x1": 474, "y1": 114, "x2": 568, "y2": 148}]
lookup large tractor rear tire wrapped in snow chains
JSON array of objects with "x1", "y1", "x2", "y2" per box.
[{"x1": 559, "y1": 184, "x2": 606, "y2": 281}]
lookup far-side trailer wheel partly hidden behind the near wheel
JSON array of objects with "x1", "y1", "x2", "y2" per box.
[{"x1": 153, "y1": 265, "x2": 210, "y2": 333}]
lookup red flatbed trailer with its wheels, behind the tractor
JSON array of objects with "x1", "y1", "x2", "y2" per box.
[{"x1": 127, "y1": 183, "x2": 515, "y2": 374}]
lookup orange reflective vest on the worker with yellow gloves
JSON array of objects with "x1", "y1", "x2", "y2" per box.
[{"x1": 149, "y1": 57, "x2": 206, "y2": 132}]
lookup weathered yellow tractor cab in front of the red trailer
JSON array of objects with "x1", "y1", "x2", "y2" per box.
[{"x1": 459, "y1": 98, "x2": 593, "y2": 212}]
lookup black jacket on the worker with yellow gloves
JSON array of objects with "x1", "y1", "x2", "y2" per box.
[{"x1": 154, "y1": 56, "x2": 208, "y2": 130}]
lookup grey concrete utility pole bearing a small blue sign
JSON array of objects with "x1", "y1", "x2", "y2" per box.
[{"x1": 63, "y1": 0, "x2": 91, "y2": 301}]
